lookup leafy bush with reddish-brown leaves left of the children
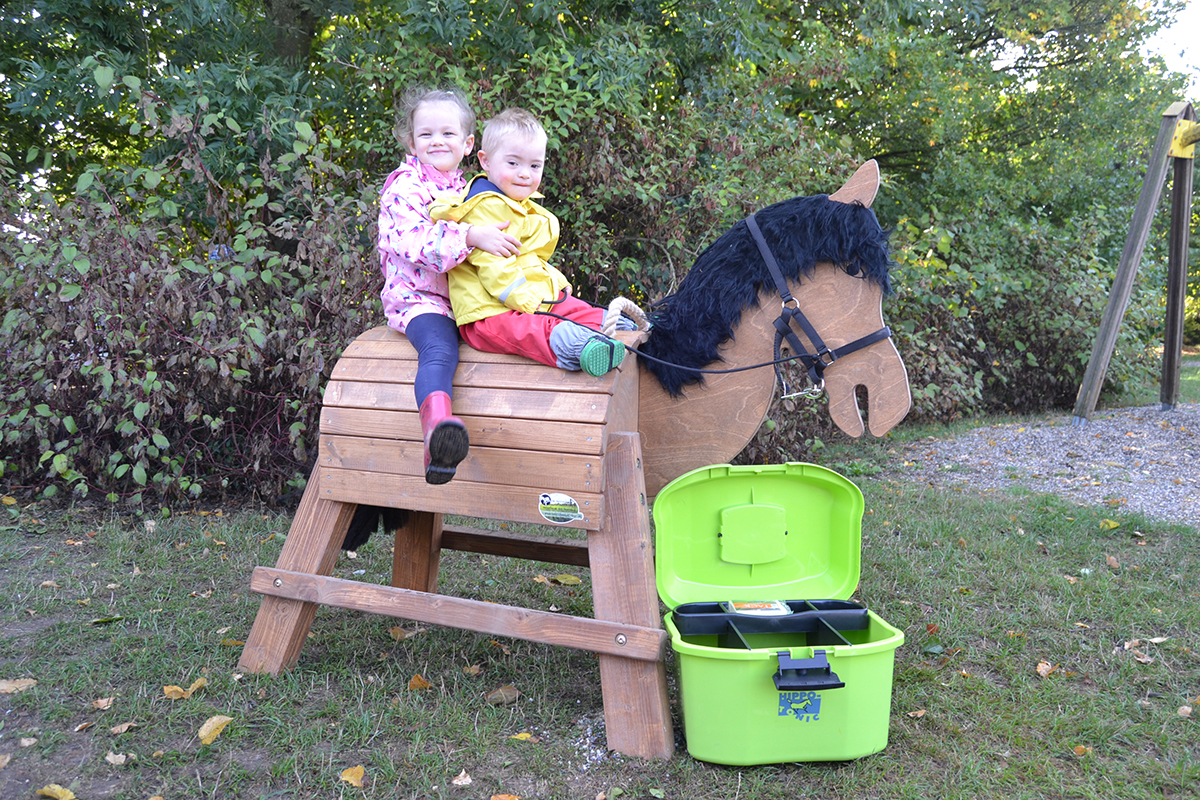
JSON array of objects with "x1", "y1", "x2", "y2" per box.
[{"x1": 0, "y1": 107, "x2": 378, "y2": 504}]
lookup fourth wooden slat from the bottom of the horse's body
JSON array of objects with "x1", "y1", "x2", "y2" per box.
[{"x1": 324, "y1": 380, "x2": 608, "y2": 425}]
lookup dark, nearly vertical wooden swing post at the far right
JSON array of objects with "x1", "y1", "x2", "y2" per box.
[{"x1": 1158, "y1": 106, "x2": 1195, "y2": 411}]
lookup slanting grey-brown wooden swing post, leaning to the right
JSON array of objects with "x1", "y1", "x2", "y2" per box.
[{"x1": 1070, "y1": 102, "x2": 1190, "y2": 426}]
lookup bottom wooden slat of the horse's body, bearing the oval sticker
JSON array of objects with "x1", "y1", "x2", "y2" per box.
[{"x1": 320, "y1": 468, "x2": 604, "y2": 530}]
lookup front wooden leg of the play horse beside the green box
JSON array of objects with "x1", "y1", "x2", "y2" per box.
[{"x1": 588, "y1": 433, "x2": 674, "y2": 758}]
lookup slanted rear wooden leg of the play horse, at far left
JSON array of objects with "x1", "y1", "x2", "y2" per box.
[{"x1": 238, "y1": 470, "x2": 356, "y2": 675}]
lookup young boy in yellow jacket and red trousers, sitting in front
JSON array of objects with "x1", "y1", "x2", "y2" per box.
[{"x1": 430, "y1": 109, "x2": 625, "y2": 375}]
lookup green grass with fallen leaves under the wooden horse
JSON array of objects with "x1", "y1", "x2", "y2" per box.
[{"x1": 0, "y1": 479, "x2": 1200, "y2": 800}]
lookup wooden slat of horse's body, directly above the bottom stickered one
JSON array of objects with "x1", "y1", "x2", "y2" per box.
[{"x1": 319, "y1": 435, "x2": 604, "y2": 492}]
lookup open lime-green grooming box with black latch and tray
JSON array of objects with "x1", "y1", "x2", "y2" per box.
[{"x1": 654, "y1": 463, "x2": 904, "y2": 765}]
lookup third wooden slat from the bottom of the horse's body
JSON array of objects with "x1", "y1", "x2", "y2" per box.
[{"x1": 320, "y1": 408, "x2": 605, "y2": 455}]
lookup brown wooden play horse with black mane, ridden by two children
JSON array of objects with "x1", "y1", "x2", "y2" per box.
[{"x1": 239, "y1": 162, "x2": 910, "y2": 758}]
